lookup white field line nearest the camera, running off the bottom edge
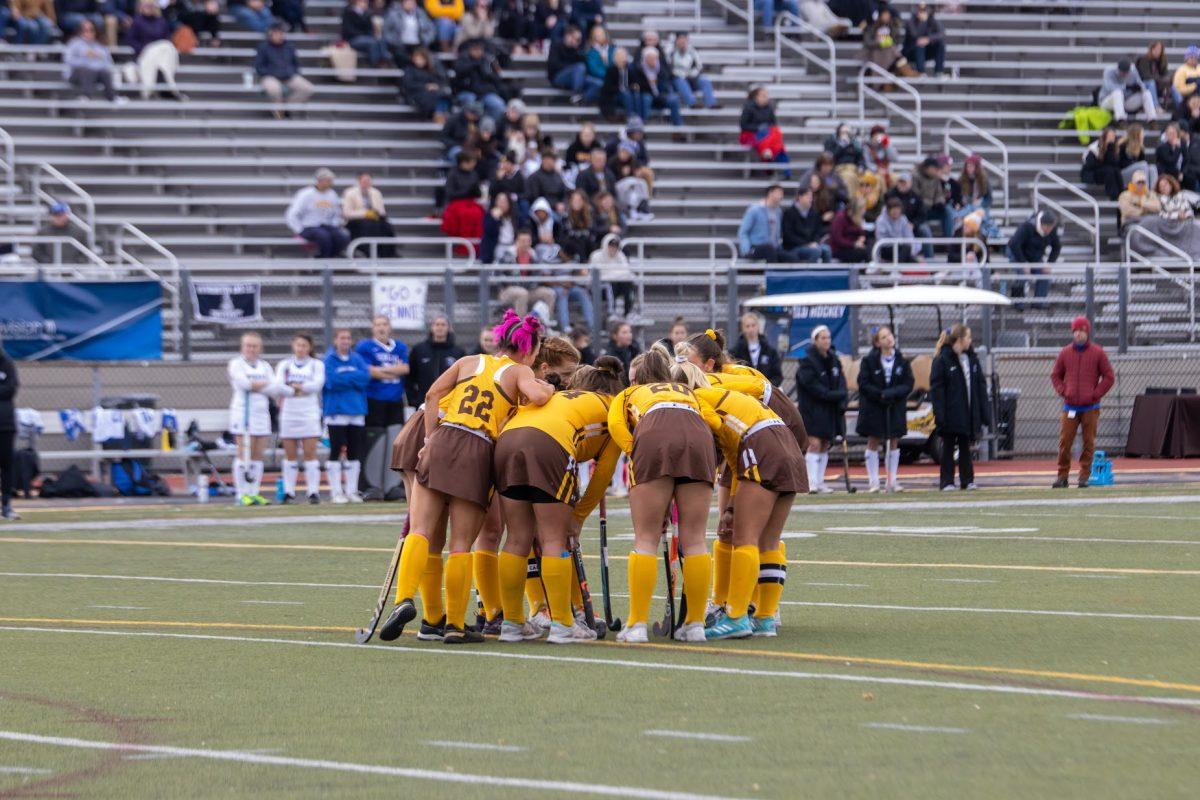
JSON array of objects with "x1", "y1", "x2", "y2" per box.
[{"x1": 0, "y1": 730, "x2": 748, "y2": 800}]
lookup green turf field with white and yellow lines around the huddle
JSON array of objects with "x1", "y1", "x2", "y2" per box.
[{"x1": 0, "y1": 488, "x2": 1200, "y2": 800}]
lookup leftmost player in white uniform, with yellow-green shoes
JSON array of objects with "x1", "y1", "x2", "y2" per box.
[{"x1": 228, "y1": 333, "x2": 275, "y2": 506}]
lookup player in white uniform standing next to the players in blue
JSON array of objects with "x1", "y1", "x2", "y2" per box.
[{"x1": 275, "y1": 333, "x2": 325, "y2": 505}]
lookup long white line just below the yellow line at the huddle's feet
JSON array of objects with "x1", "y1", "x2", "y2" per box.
[{"x1": 0, "y1": 625, "x2": 1200, "y2": 708}]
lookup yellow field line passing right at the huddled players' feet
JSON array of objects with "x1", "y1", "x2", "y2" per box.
[{"x1": 0, "y1": 616, "x2": 1200, "y2": 693}]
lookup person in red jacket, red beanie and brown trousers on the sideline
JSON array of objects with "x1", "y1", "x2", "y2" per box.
[{"x1": 1050, "y1": 317, "x2": 1116, "y2": 489}]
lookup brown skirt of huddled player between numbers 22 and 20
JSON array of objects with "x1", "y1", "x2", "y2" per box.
[{"x1": 492, "y1": 428, "x2": 578, "y2": 506}]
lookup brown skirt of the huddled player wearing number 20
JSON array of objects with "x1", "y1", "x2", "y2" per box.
[{"x1": 631, "y1": 408, "x2": 716, "y2": 485}]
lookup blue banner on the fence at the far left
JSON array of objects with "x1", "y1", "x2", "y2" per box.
[{"x1": 0, "y1": 281, "x2": 162, "y2": 361}]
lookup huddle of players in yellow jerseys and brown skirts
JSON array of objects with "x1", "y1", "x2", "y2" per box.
[{"x1": 377, "y1": 309, "x2": 809, "y2": 644}]
